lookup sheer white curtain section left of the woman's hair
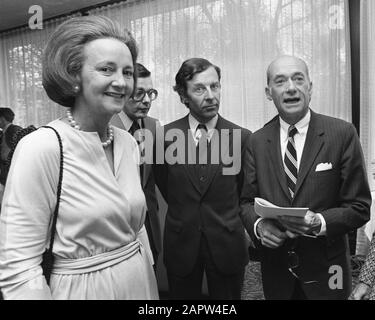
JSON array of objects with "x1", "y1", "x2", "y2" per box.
[{"x1": 0, "y1": 18, "x2": 79, "y2": 126}]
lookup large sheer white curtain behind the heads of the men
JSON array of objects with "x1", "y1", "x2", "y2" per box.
[{"x1": 91, "y1": 0, "x2": 351, "y2": 130}]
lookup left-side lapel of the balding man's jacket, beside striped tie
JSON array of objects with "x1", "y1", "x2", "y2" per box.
[{"x1": 267, "y1": 119, "x2": 290, "y2": 199}]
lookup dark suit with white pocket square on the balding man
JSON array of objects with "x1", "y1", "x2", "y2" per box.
[{"x1": 246, "y1": 111, "x2": 371, "y2": 299}]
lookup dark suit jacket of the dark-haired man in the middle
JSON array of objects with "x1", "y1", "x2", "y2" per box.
[{"x1": 154, "y1": 116, "x2": 254, "y2": 276}]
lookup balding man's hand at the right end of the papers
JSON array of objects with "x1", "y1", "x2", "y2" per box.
[{"x1": 278, "y1": 210, "x2": 322, "y2": 235}]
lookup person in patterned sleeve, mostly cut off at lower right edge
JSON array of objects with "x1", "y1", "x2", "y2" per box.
[{"x1": 350, "y1": 234, "x2": 375, "y2": 300}]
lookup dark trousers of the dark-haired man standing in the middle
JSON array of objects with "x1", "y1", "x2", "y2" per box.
[{"x1": 167, "y1": 236, "x2": 245, "y2": 300}]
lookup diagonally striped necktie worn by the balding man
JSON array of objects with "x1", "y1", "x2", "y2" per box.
[{"x1": 284, "y1": 126, "x2": 298, "y2": 199}]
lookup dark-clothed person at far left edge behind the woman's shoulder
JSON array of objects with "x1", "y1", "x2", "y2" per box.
[{"x1": 0, "y1": 108, "x2": 22, "y2": 186}]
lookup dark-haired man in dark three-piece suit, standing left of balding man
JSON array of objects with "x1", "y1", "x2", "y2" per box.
[{"x1": 155, "y1": 58, "x2": 250, "y2": 299}]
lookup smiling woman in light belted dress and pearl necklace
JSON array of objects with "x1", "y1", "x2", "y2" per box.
[{"x1": 0, "y1": 16, "x2": 158, "y2": 299}]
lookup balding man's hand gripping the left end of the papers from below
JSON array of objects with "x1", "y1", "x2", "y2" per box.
[{"x1": 257, "y1": 219, "x2": 295, "y2": 249}]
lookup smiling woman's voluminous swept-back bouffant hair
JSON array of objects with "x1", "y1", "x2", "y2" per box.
[{"x1": 42, "y1": 16, "x2": 138, "y2": 107}]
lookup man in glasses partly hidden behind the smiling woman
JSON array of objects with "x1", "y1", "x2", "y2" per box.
[{"x1": 111, "y1": 63, "x2": 162, "y2": 268}]
